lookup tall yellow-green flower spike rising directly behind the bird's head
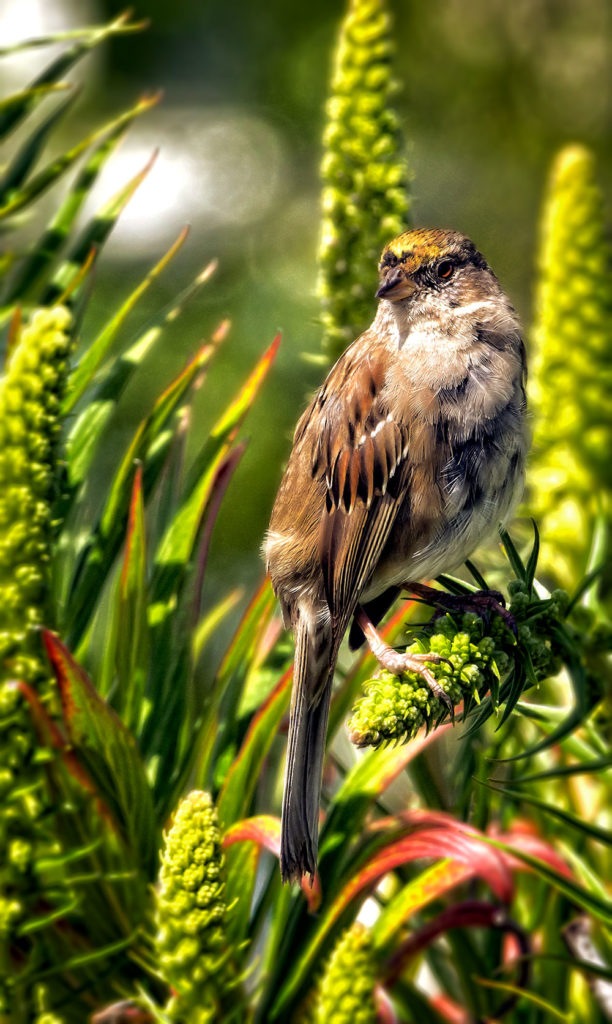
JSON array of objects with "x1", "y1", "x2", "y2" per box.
[{"x1": 318, "y1": 0, "x2": 409, "y2": 360}]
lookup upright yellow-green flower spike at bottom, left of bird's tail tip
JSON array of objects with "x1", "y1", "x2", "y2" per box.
[{"x1": 157, "y1": 791, "x2": 236, "y2": 1024}]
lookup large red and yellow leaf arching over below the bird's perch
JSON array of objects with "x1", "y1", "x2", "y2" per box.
[{"x1": 274, "y1": 827, "x2": 513, "y2": 1013}]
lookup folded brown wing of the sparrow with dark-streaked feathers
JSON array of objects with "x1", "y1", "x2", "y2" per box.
[{"x1": 311, "y1": 336, "x2": 408, "y2": 622}]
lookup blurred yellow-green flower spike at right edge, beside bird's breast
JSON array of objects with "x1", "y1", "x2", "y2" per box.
[{"x1": 528, "y1": 145, "x2": 612, "y2": 586}]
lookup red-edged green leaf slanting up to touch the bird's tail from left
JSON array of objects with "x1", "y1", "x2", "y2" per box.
[{"x1": 217, "y1": 669, "x2": 293, "y2": 827}]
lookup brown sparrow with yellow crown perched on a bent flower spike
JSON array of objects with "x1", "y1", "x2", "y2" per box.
[{"x1": 264, "y1": 228, "x2": 528, "y2": 882}]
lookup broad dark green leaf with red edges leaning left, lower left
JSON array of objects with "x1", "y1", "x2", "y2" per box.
[{"x1": 42, "y1": 630, "x2": 158, "y2": 878}]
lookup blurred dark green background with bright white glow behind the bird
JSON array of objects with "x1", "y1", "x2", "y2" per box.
[{"x1": 0, "y1": 0, "x2": 612, "y2": 602}]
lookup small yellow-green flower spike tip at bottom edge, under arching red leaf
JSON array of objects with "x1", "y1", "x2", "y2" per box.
[{"x1": 313, "y1": 923, "x2": 378, "y2": 1024}]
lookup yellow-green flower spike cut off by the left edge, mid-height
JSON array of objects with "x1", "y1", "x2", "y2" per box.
[{"x1": 0, "y1": 306, "x2": 71, "y2": 681}]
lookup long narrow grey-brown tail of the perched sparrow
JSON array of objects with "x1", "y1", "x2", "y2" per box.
[{"x1": 280, "y1": 617, "x2": 338, "y2": 882}]
